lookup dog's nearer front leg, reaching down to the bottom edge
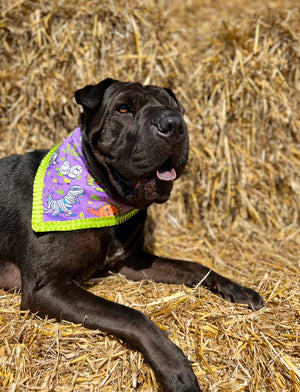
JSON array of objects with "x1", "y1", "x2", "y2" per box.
[{"x1": 21, "y1": 278, "x2": 200, "y2": 392}]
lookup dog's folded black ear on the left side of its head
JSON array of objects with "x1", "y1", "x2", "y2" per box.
[{"x1": 75, "y1": 78, "x2": 116, "y2": 110}]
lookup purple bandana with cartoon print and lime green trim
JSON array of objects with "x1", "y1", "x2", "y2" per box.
[{"x1": 32, "y1": 128, "x2": 139, "y2": 232}]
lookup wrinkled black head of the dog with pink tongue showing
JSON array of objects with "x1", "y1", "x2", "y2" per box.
[{"x1": 75, "y1": 79, "x2": 188, "y2": 208}]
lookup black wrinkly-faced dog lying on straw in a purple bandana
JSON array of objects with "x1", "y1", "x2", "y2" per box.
[{"x1": 0, "y1": 79, "x2": 263, "y2": 392}]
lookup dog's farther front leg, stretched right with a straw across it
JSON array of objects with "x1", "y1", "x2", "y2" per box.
[{"x1": 118, "y1": 251, "x2": 264, "y2": 310}]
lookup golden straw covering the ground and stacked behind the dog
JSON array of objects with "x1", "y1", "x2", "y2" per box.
[{"x1": 0, "y1": 0, "x2": 300, "y2": 392}]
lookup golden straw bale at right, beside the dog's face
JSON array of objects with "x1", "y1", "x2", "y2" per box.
[{"x1": 178, "y1": 7, "x2": 300, "y2": 229}]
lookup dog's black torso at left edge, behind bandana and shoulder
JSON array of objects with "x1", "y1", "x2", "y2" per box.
[{"x1": 0, "y1": 150, "x2": 47, "y2": 289}]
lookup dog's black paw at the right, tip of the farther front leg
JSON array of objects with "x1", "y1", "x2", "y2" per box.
[{"x1": 211, "y1": 277, "x2": 265, "y2": 310}]
